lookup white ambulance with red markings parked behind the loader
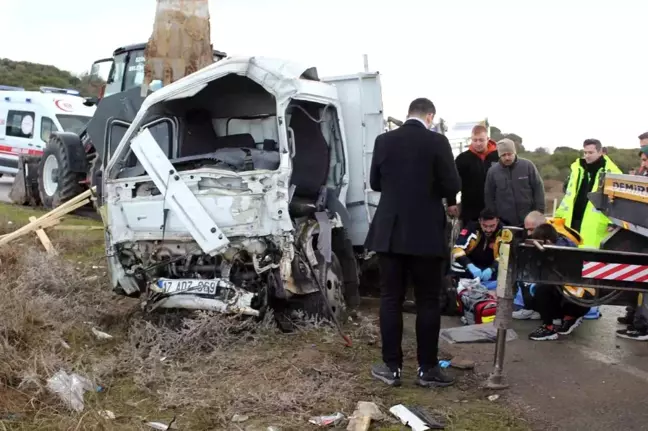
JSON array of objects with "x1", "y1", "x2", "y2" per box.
[{"x1": 0, "y1": 85, "x2": 96, "y2": 176}]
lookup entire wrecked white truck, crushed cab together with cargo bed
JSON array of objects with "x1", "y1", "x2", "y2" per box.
[{"x1": 89, "y1": 57, "x2": 384, "y2": 317}]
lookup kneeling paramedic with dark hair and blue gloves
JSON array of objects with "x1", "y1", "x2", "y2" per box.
[{"x1": 450, "y1": 209, "x2": 502, "y2": 282}]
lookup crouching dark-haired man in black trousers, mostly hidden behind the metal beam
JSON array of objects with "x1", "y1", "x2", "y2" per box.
[{"x1": 529, "y1": 223, "x2": 595, "y2": 341}]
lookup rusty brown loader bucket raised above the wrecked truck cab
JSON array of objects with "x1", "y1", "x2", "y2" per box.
[{"x1": 142, "y1": 0, "x2": 214, "y2": 97}]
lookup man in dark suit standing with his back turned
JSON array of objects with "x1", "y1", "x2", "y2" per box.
[{"x1": 365, "y1": 98, "x2": 461, "y2": 387}]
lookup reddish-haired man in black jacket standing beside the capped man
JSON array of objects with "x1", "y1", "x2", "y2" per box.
[{"x1": 448, "y1": 124, "x2": 499, "y2": 227}]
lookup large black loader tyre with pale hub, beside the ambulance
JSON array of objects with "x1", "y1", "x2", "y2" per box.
[{"x1": 38, "y1": 136, "x2": 83, "y2": 208}]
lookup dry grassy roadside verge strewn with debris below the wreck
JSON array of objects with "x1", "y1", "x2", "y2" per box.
[{"x1": 0, "y1": 204, "x2": 529, "y2": 431}]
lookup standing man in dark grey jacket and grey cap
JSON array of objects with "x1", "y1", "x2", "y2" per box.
[{"x1": 484, "y1": 138, "x2": 545, "y2": 226}]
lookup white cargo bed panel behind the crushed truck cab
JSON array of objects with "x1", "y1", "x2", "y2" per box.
[{"x1": 321, "y1": 73, "x2": 385, "y2": 246}]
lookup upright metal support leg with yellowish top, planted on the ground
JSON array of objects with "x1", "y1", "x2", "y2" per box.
[{"x1": 484, "y1": 228, "x2": 516, "y2": 389}]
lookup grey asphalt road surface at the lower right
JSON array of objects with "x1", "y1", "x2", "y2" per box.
[{"x1": 432, "y1": 306, "x2": 648, "y2": 431}]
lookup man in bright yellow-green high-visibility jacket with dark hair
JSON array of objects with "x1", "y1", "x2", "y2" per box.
[{"x1": 555, "y1": 139, "x2": 622, "y2": 248}]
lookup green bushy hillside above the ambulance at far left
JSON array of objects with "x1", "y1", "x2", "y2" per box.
[{"x1": 0, "y1": 58, "x2": 97, "y2": 96}]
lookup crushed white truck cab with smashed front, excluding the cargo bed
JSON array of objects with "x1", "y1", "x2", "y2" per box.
[{"x1": 100, "y1": 58, "x2": 354, "y2": 316}]
